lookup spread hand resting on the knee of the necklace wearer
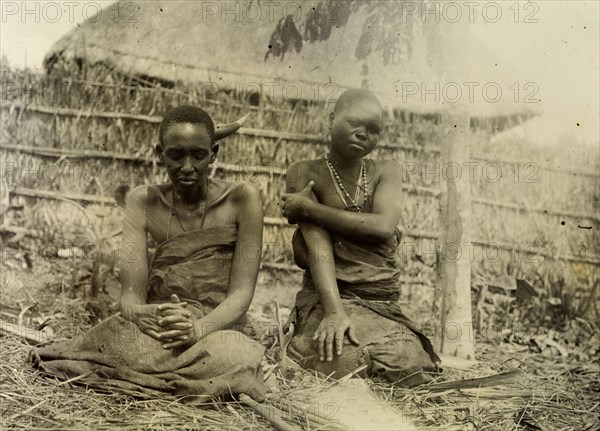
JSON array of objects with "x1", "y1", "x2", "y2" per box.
[{"x1": 313, "y1": 310, "x2": 359, "y2": 361}]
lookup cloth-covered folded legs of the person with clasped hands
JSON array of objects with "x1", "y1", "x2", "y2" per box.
[{"x1": 30, "y1": 316, "x2": 264, "y2": 400}]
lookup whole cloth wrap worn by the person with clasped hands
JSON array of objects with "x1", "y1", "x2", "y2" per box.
[{"x1": 30, "y1": 187, "x2": 265, "y2": 401}]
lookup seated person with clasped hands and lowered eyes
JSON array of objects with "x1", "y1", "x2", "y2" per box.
[{"x1": 31, "y1": 106, "x2": 265, "y2": 401}]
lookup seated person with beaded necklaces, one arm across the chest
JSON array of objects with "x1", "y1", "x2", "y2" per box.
[{"x1": 283, "y1": 90, "x2": 439, "y2": 385}]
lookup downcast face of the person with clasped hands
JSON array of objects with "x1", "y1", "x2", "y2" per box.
[{"x1": 159, "y1": 123, "x2": 216, "y2": 192}]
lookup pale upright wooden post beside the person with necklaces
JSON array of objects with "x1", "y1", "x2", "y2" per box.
[{"x1": 436, "y1": 106, "x2": 475, "y2": 360}]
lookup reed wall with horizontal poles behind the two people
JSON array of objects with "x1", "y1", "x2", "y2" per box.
[{"x1": 0, "y1": 72, "x2": 600, "y2": 308}]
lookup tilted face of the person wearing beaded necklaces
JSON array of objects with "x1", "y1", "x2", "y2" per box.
[{"x1": 330, "y1": 100, "x2": 383, "y2": 159}]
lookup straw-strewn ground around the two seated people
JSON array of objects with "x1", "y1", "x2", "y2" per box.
[{"x1": 0, "y1": 259, "x2": 600, "y2": 431}]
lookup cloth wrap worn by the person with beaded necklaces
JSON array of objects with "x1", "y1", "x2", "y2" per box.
[{"x1": 288, "y1": 221, "x2": 440, "y2": 385}]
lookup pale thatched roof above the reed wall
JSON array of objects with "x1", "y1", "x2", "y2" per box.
[{"x1": 45, "y1": 0, "x2": 523, "y2": 117}]
